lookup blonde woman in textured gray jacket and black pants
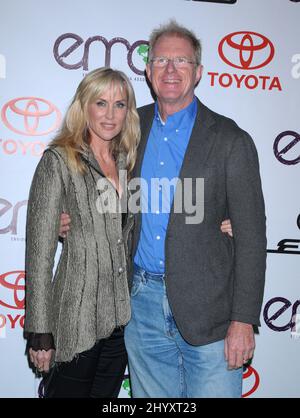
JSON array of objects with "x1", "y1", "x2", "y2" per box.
[{"x1": 25, "y1": 68, "x2": 140, "y2": 397}]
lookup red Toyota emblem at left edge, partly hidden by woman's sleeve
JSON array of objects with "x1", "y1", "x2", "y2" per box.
[{"x1": 0, "y1": 270, "x2": 25, "y2": 309}]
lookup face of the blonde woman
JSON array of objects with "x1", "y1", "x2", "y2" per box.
[{"x1": 88, "y1": 84, "x2": 128, "y2": 141}]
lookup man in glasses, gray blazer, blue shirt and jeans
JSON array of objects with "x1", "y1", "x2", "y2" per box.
[{"x1": 125, "y1": 21, "x2": 266, "y2": 398}]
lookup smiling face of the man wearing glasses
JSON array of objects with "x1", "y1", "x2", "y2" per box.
[{"x1": 146, "y1": 35, "x2": 202, "y2": 111}]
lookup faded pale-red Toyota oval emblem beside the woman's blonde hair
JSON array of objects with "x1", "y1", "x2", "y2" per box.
[{"x1": 1, "y1": 97, "x2": 61, "y2": 136}]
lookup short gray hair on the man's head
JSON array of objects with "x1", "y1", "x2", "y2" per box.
[{"x1": 148, "y1": 20, "x2": 202, "y2": 65}]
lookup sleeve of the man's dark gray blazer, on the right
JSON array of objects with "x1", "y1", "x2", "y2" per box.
[{"x1": 226, "y1": 130, "x2": 266, "y2": 325}]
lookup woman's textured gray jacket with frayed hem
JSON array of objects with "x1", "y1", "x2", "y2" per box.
[{"x1": 25, "y1": 148, "x2": 133, "y2": 362}]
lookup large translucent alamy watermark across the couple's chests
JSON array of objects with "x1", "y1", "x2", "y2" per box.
[{"x1": 96, "y1": 170, "x2": 204, "y2": 225}]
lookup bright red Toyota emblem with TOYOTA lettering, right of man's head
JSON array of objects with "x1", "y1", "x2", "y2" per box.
[{"x1": 208, "y1": 31, "x2": 282, "y2": 91}]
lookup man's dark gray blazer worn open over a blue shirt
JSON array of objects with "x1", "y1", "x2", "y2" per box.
[{"x1": 133, "y1": 101, "x2": 266, "y2": 345}]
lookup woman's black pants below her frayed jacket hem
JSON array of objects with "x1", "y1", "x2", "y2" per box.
[{"x1": 42, "y1": 328, "x2": 127, "y2": 398}]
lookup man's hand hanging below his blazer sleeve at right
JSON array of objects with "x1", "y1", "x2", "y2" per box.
[{"x1": 225, "y1": 321, "x2": 255, "y2": 369}]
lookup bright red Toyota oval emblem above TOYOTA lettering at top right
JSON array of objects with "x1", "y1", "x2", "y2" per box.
[{"x1": 219, "y1": 32, "x2": 275, "y2": 70}]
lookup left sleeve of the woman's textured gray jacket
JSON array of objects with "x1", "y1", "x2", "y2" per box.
[{"x1": 25, "y1": 151, "x2": 64, "y2": 333}]
